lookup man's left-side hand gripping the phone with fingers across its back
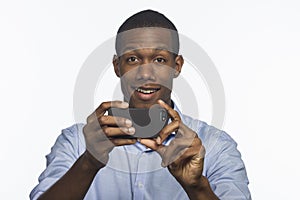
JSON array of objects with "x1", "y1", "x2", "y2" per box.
[{"x1": 83, "y1": 101, "x2": 136, "y2": 167}]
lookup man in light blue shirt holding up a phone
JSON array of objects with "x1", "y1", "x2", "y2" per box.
[{"x1": 30, "y1": 10, "x2": 251, "y2": 199}]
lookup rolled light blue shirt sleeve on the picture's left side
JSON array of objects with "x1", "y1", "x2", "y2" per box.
[{"x1": 30, "y1": 125, "x2": 79, "y2": 200}]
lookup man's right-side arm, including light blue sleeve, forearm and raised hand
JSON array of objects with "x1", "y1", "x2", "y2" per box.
[{"x1": 141, "y1": 99, "x2": 251, "y2": 200}]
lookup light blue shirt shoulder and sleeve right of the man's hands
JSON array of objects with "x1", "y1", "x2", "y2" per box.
[{"x1": 181, "y1": 115, "x2": 251, "y2": 199}]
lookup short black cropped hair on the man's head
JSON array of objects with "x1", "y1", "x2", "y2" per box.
[{"x1": 115, "y1": 10, "x2": 179, "y2": 55}]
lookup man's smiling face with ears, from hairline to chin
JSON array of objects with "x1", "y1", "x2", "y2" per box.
[{"x1": 113, "y1": 28, "x2": 183, "y2": 108}]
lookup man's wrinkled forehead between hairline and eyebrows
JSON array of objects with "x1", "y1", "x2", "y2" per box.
[{"x1": 116, "y1": 27, "x2": 176, "y2": 55}]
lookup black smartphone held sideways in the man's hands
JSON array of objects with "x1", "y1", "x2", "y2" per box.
[{"x1": 108, "y1": 105, "x2": 169, "y2": 138}]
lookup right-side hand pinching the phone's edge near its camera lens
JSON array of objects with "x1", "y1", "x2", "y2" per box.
[{"x1": 140, "y1": 100, "x2": 205, "y2": 190}]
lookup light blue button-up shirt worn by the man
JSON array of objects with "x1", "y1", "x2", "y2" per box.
[{"x1": 30, "y1": 105, "x2": 251, "y2": 200}]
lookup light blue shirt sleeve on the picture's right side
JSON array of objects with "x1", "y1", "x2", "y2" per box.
[{"x1": 204, "y1": 130, "x2": 251, "y2": 200}]
